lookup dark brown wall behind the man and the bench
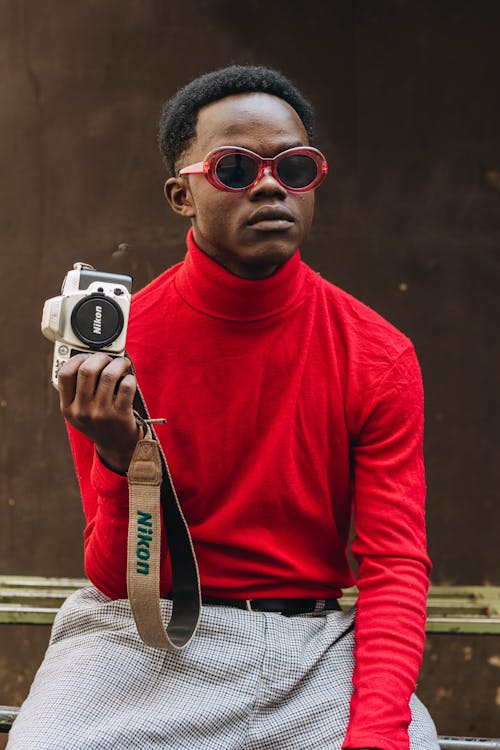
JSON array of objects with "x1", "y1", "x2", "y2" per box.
[{"x1": 0, "y1": 0, "x2": 500, "y2": 735}]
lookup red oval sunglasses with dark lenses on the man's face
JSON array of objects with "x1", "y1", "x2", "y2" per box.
[{"x1": 179, "y1": 146, "x2": 328, "y2": 193}]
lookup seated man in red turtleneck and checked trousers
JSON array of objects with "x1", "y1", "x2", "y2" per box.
[{"x1": 6, "y1": 67, "x2": 438, "y2": 750}]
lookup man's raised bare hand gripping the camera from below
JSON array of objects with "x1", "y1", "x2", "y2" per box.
[{"x1": 58, "y1": 352, "x2": 141, "y2": 472}]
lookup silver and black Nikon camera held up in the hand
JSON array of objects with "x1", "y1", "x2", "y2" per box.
[{"x1": 41, "y1": 263, "x2": 132, "y2": 388}]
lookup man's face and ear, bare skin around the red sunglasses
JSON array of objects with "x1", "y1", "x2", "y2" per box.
[{"x1": 166, "y1": 93, "x2": 314, "y2": 279}]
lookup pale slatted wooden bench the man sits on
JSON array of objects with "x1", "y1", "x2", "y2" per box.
[{"x1": 0, "y1": 576, "x2": 500, "y2": 750}]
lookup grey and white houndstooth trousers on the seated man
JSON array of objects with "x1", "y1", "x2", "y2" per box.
[{"x1": 8, "y1": 586, "x2": 439, "y2": 750}]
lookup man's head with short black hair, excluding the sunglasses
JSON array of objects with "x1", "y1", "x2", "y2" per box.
[{"x1": 159, "y1": 66, "x2": 326, "y2": 278}]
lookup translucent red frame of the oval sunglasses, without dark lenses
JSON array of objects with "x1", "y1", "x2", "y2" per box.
[{"x1": 179, "y1": 146, "x2": 328, "y2": 193}]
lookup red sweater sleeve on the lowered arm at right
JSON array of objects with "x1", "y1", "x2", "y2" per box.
[{"x1": 343, "y1": 346, "x2": 430, "y2": 750}]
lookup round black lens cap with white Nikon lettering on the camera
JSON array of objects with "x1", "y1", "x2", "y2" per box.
[{"x1": 71, "y1": 293, "x2": 123, "y2": 349}]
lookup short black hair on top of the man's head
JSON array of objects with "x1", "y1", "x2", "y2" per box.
[{"x1": 158, "y1": 65, "x2": 314, "y2": 174}]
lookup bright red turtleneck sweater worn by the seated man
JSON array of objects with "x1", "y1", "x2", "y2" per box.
[{"x1": 70, "y1": 228, "x2": 429, "y2": 750}]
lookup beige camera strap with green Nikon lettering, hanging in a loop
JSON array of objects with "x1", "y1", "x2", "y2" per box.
[{"x1": 127, "y1": 376, "x2": 201, "y2": 651}]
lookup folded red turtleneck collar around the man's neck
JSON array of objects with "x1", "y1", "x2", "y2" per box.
[{"x1": 175, "y1": 229, "x2": 307, "y2": 321}]
